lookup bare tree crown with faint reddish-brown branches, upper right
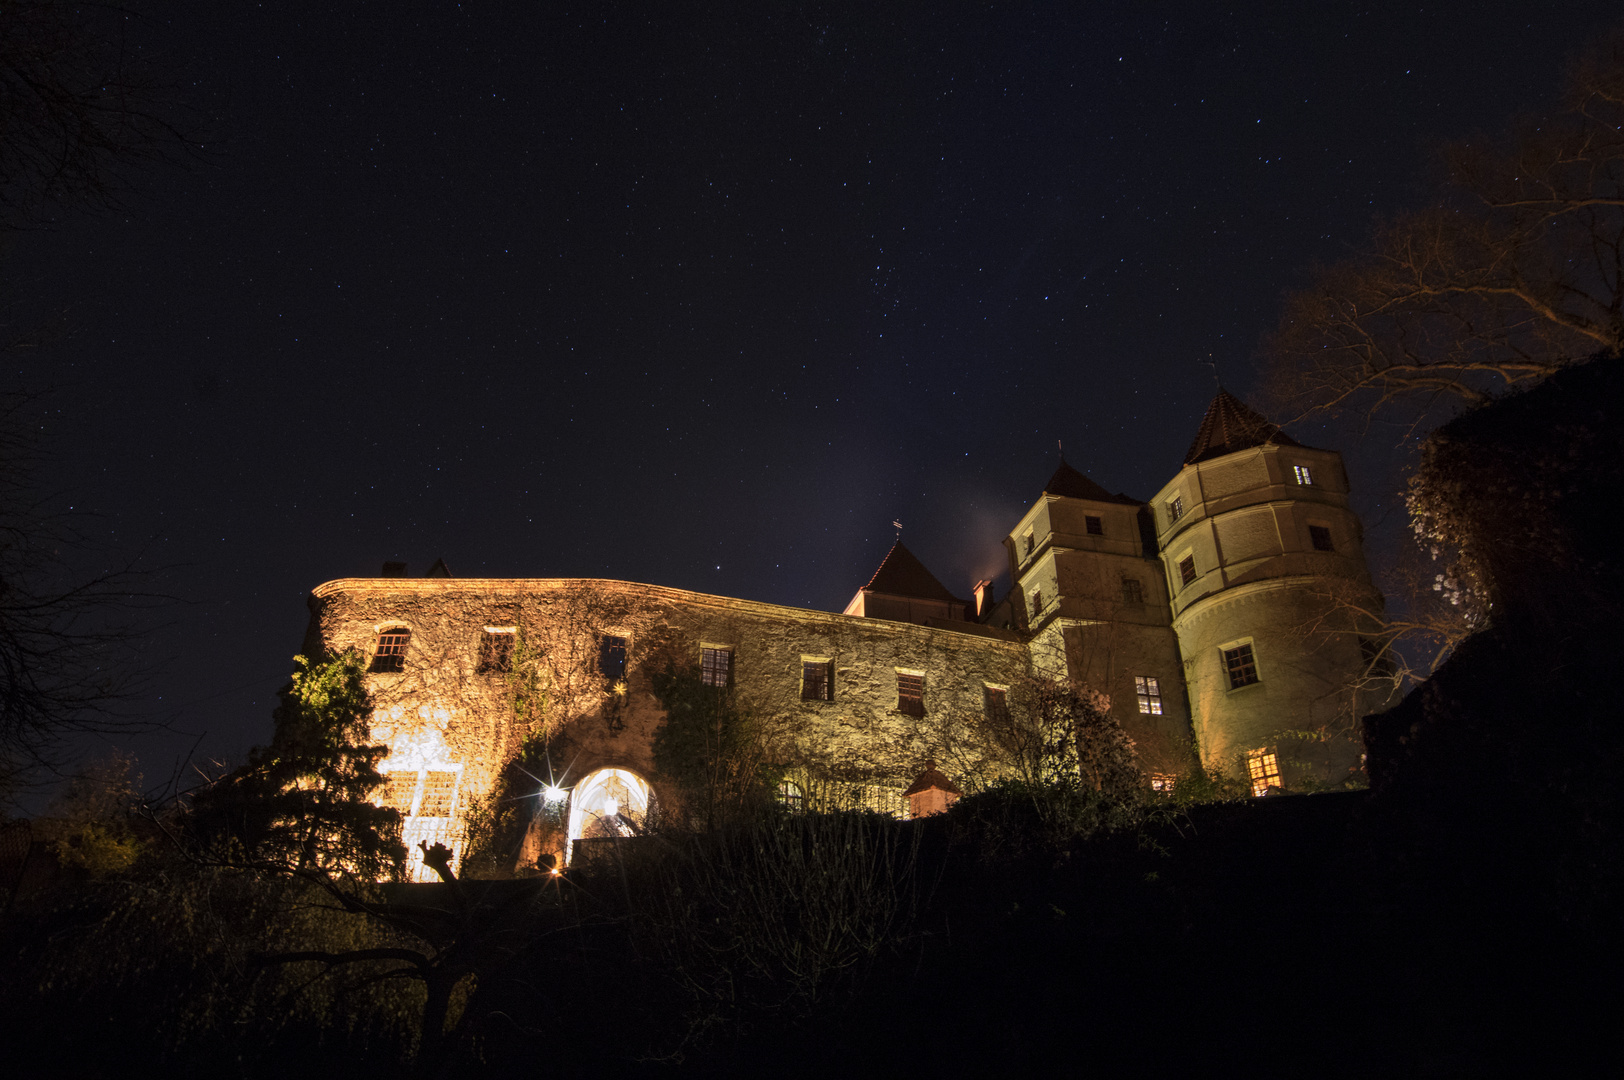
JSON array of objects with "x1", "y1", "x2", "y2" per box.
[{"x1": 1265, "y1": 31, "x2": 1624, "y2": 424}]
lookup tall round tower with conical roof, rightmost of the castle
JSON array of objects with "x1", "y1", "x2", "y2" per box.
[{"x1": 1151, "y1": 390, "x2": 1382, "y2": 794}]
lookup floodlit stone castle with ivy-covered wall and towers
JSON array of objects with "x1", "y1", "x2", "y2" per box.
[{"x1": 305, "y1": 390, "x2": 1384, "y2": 874}]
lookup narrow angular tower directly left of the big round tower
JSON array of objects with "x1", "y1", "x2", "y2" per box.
[{"x1": 1004, "y1": 461, "x2": 1189, "y2": 771}]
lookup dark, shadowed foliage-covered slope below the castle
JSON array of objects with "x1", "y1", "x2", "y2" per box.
[{"x1": 0, "y1": 766, "x2": 1619, "y2": 1077}]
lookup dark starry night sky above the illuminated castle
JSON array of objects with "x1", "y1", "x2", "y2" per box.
[{"x1": 0, "y1": 0, "x2": 1618, "y2": 783}]
